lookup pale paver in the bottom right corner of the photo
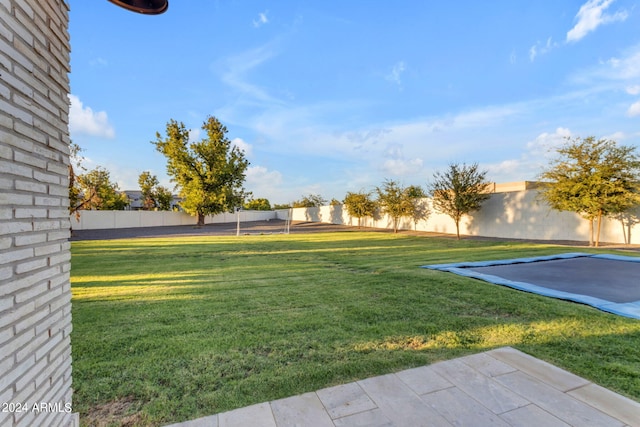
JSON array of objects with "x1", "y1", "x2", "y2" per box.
[{"x1": 569, "y1": 384, "x2": 640, "y2": 426}]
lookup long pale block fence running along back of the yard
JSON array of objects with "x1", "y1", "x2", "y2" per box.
[{"x1": 71, "y1": 182, "x2": 640, "y2": 244}]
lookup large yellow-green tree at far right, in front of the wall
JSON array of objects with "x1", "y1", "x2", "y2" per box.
[{"x1": 540, "y1": 136, "x2": 640, "y2": 246}]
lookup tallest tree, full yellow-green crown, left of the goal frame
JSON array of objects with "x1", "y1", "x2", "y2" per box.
[{"x1": 152, "y1": 117, "x2": 249, "y2": 225}]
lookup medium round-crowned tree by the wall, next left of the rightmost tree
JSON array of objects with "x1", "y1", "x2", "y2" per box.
[{"x1": 430, "y1": 163, "x2": 491, "y2": 240}]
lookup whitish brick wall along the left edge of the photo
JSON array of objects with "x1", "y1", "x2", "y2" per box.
[{"x1": 0, "y1": 0, "x2": 78, "y2": 426}]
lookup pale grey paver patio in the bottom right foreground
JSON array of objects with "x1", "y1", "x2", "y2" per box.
[{"x1": 170, "y1": 347, "x2": 640, "y2": 427}]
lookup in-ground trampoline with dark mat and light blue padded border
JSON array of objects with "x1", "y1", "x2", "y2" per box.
[{"x1": 423, "y1": 253, "x2": 640, "y2": 319}]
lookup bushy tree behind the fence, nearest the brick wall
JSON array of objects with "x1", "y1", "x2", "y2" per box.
[{"x1": 76, "y1": 166, "x2": 129, "y2": 210}]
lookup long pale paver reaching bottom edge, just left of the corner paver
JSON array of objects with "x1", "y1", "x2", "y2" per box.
[{"x1": 496, "y1": 371, "x2": 623, "y2": 427}]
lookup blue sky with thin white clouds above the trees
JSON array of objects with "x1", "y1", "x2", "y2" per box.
[{"x1": 68, "y1": 0, "x2": 640, "y2": 203}]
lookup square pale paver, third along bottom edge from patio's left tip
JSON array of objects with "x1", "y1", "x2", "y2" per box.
[{"x1": 271, "y1": 393, "x2": 334, "y2": 427}]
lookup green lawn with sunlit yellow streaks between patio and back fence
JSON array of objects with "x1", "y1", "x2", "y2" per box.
[{"x1": 71, "y1": 232, "x2": 640, "y2": 426}]
